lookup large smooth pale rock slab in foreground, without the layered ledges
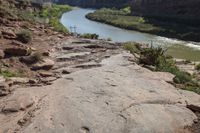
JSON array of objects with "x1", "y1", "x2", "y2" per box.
[{"x1": 23, "y1": 53, "x2": 200, "y2": 133}]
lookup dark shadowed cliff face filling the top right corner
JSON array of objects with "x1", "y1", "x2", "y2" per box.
[{"x1": 131, "y1": 0, "x2": 200, "y2": 23}]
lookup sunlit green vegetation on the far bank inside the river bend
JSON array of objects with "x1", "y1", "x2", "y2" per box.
[{"x1": 86, "y1": 8, "x2": 160, "y2": 32}]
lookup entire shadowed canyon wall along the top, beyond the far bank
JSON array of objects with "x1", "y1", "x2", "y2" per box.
[{"x1": 54, "y1": 0, "x2": 200, "y2": 26}]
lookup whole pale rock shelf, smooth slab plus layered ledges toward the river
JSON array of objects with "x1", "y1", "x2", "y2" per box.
[{"x1": 0, "y1": 39, "x2": 200, "y2": 133}]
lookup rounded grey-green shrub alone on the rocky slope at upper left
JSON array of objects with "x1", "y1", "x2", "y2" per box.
[{"x1": 17, "y1": 30, "x2": 32, "y2": 43}]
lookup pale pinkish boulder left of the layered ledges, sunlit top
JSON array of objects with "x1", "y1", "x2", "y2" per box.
[{"x1": 31, "y1": 58, "x2": 55, "y2": 70}]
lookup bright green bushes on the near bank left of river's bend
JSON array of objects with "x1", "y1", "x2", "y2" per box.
[{"x1": 40, "y1": 4, "x2": 72, "y2": 33}]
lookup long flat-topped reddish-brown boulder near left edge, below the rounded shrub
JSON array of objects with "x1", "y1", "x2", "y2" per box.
[{"x1": 4, "y1": 47, "x2": 30, "y2": 56}]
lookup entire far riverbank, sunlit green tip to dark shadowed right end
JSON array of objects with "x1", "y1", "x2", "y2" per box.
[{"x1": 86, "y1": 8, "x2": 200, "y2": 42}]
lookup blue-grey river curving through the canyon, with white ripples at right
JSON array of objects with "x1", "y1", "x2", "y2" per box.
[{"x1": 61, "y1": 8, "x2": 200, "y2": 49}]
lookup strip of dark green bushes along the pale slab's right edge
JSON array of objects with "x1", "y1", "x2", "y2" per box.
[{"x1": 124, "y1": 43, "x2": 200, "y2": 94}]
